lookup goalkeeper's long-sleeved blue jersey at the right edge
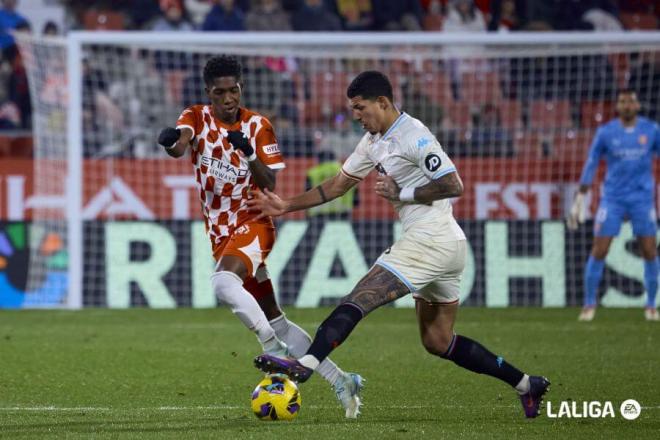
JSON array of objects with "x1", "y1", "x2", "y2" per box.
[{"x1": 580, "y1": 116, "x2": 660, "y2": 200}]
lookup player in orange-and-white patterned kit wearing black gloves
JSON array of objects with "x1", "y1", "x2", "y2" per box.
[{"x1": 158, "y1": 56, "x2": 361, "y2": 417}]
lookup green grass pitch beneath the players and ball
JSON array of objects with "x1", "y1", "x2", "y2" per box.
[{"x1": 0, "y1": 308, "x2": 660, "y2": 440}]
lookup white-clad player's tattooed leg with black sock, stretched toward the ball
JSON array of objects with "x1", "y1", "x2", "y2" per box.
[{"x1": 307, "y1": 265, "x2": 410, "y2": 362}]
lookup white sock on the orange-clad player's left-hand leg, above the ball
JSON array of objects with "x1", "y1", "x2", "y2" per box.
[{"x1": 211, "y1": 271, "x2": 284, "y2": 353}]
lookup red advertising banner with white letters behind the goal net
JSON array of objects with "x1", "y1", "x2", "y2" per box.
[{"x1": 0, "y1": 158, "x2": 628, "y2": 221}]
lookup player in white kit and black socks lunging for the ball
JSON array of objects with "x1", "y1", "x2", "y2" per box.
[{"x1": 248, "y1": 71, "x2": 550, "y2": 418}]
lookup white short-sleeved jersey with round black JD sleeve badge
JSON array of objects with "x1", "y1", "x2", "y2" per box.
[{"x1": 342, "y1": 113, "x2": 465, "y2": 241}]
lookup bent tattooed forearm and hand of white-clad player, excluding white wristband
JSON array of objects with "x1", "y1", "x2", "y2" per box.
[{"x1": 376, "y1": 172, "x2": 463, "y2": 203}]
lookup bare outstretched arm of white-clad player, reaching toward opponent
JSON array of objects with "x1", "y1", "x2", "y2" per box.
[{"x1": 247, "y1": 173, "x2": 358, "y2": 218}]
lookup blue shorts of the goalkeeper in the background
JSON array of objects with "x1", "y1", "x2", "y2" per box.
[{"x1": 594, "y1": 198, "x2": 657, "y2": 237}]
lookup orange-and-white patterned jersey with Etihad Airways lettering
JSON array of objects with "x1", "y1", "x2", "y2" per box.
[{"x1": 176, "y1": 105, "x2": 285, "y2": 244}]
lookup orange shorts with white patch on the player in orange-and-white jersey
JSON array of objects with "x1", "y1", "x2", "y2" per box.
[{"x1": 213, "y1": 221, "x2": 275, "y2": 277}]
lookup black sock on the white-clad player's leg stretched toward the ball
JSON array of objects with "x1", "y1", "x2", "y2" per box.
[{"x1": 303, "y1": 303, "x2": 364, "y2": 365}]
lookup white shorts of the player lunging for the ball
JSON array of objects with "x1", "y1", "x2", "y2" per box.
[{"x1": 375, "y1": 231, "x2": 467, "y2": 304}]
